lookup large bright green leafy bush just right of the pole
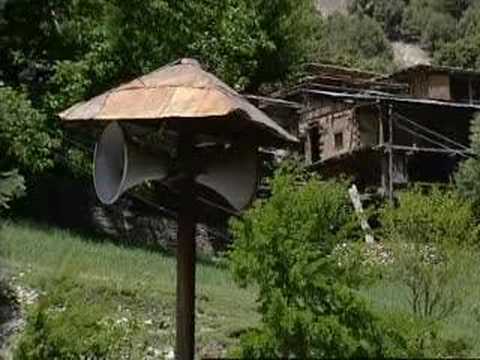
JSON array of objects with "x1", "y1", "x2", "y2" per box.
[{"x1": 230, "y1": 169, "x2": 393, "y2": 358}]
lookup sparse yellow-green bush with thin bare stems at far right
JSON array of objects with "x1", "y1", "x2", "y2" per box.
[{"x1": 380, "y1": 188, "x2": 478, "y2": 357}]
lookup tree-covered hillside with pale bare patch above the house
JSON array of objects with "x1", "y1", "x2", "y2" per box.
[{"x1": 316, "y1": 0, "x2": 480, "y2": 69}]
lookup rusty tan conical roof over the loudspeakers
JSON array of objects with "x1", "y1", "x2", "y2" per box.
[{"x1": 59, "y1": 59, "x2": 298, "y2": 142}]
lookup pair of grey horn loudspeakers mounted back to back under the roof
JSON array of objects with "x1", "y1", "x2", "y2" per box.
[{"x1": 94, "y1": 122, "x2": 258, "y2": 210}]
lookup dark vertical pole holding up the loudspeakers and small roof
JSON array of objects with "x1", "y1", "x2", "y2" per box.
[{"x1": 175, "y1": 132, "x2": 196, "y2": 360}]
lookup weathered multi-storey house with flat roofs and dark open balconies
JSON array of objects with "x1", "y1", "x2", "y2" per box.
[{"x1": 273, "y1": 64, "x2": 480, "y2": 198}]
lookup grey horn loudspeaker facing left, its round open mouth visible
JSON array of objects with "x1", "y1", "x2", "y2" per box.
[{"x1": 93, "y1": 122, "x2": 168, "y2": 205}]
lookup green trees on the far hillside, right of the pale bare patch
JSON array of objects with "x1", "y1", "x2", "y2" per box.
[{"x1": 351, "y1": 0, "x2": 480, "y2": 69}]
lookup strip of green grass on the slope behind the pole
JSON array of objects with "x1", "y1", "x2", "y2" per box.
[{"x1": 0, "y1": 223, "x2": 259, "y2": 355}]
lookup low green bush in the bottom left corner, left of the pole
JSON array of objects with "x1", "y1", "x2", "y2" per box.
[{"x1": 14, "y1": 278, "x2": 143, "y2": 360}]
